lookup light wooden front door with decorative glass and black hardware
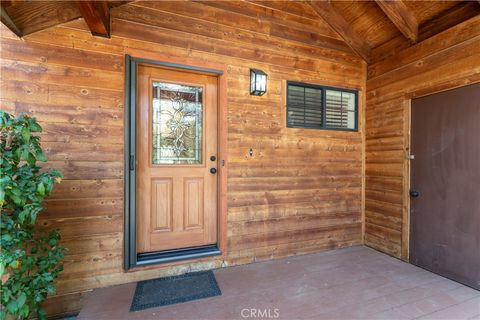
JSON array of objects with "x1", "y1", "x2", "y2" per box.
[{"x1": 136, "y1": 65, "x2": 218, "y2": 253}]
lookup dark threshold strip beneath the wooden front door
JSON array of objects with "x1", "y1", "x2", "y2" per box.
[{"x1": 136, "y1": 244, "x2": 222, "y2": 266}]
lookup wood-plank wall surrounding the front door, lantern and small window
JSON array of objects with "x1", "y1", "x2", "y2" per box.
[{"x1": 1, "y1": 2, "x2": 364, "y2": 314}]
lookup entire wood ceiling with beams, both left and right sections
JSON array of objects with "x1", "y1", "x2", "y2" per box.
[{"x1": 1, "y1": 0, "x2": 480, "y2": 63}]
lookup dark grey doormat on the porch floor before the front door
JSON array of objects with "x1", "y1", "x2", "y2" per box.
[{"x1": 130, "y1": 271, "x2": 222, "y2": 311}]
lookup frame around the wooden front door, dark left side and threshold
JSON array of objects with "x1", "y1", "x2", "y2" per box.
[{"x1": 124, "y1": 54, "x2": 226, "y2": 270}]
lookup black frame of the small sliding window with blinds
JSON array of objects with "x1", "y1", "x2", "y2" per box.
[{"x1": 285, "y1": 80, "x2": 359, "y2": 132}]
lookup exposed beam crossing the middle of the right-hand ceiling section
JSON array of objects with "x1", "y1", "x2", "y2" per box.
[{"x1": 375, "y1": 0, "x2": 418, "y2": 43}]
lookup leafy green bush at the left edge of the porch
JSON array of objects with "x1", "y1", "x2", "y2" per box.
[{"x1": 0, "y1": 110, "x2": 65, "y2": 319}]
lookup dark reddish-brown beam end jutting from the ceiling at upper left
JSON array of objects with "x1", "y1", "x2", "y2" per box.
[{"x1": 76, "y1": 0, "x2": 110, "y2": 38}]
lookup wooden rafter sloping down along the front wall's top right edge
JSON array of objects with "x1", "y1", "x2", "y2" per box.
[{"x1": 309, "y1": 1, "x2": 370, "y2": 62}]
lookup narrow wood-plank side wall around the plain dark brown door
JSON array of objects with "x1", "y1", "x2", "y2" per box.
[{"x1": 365, "y1": 16, "x2": 480, "y2": 260}]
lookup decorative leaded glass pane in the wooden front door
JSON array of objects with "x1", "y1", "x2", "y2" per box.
[{"x1": 152, "y1": 82, "x2": 203, "y2": 164}]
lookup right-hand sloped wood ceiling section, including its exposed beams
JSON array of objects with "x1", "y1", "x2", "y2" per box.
[{"x1": 331, "y1": 0, "x2": 480, "y2": 61}]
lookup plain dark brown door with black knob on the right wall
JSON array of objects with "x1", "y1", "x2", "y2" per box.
[{"x1": 410, "y1": 84, "x2": 480, "y2": 289}]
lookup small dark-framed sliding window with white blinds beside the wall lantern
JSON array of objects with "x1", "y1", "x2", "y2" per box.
[{"x1": 287, "y1": 81, "x2": 358, "y2": 131}]
